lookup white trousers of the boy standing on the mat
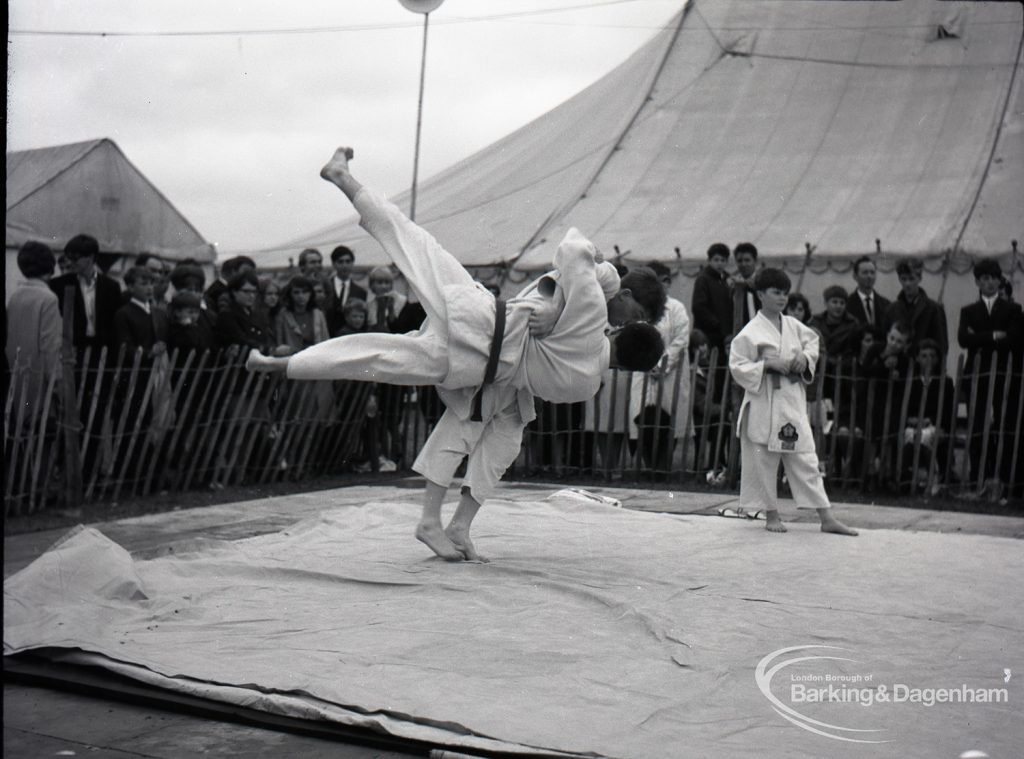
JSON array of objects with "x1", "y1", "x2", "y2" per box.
[{"x1": 739, "y1": 437, "x2": 830, "y2": 511}]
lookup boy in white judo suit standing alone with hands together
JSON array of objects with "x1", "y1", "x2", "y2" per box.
[{"x1": 729, "y1": 268, "x2": 857, "y2": 535}]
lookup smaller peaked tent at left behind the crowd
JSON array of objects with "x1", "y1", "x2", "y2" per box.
[{"x1": 6, "y1": 138, "x2": 216, "y2": 296}]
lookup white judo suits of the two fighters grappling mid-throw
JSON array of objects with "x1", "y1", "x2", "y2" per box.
[{"x1": 288, "y1": 187, "x2": 618, "y2": 502}]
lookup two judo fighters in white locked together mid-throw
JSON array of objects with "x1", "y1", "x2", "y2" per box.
[{"x1": 247, "y1": 147, "x2": 665, "y2": 561}]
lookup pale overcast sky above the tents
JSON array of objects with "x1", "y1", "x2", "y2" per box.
[{"x1": 7, "y1": 0, "x2": 682, "y2": 256}]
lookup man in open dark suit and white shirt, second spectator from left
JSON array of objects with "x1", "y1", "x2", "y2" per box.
[{"x1": 50, "y1": 235, "x2": 121, "y2": 352}]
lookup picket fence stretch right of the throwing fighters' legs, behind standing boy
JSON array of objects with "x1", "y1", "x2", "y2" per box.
[{"x1": 513, "y1": 351, "x2": 1024, "y2": 500}]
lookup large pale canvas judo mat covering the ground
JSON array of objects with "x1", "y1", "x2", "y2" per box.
[{"x1": 4, "y1": 494, "x2": 1024, "y2": 759}]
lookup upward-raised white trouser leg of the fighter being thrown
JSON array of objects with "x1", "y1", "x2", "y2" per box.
[{"x1": 353, "y1": 187, "x2": 473, "y2": 322}]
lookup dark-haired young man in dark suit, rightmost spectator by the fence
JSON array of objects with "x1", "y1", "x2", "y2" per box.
[{"x1": 956, "y1": 258, "x2": 1024, "y2": 497}]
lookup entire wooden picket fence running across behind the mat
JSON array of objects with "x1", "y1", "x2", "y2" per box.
[{"x1": 4, "y1": 349, "x2": 1024, "y2": 515}]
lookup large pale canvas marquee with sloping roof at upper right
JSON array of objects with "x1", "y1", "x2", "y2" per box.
[{"x1": 249, "y1": 0, "x2": 1024, "y2": 270}]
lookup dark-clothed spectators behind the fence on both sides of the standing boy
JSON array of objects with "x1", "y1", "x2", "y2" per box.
[{"x1": 691, "y1": 243, "x2": 1024, "y2": 498}]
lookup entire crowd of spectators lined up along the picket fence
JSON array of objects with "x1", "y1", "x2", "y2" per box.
[{"x1": 7, "y1": 235, "x2": 1024, "y2": 499}]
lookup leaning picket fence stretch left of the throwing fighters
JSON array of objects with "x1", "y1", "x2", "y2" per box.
[{"x1": 4, "y1": 348, "x2": 372, "y2": 515}]
